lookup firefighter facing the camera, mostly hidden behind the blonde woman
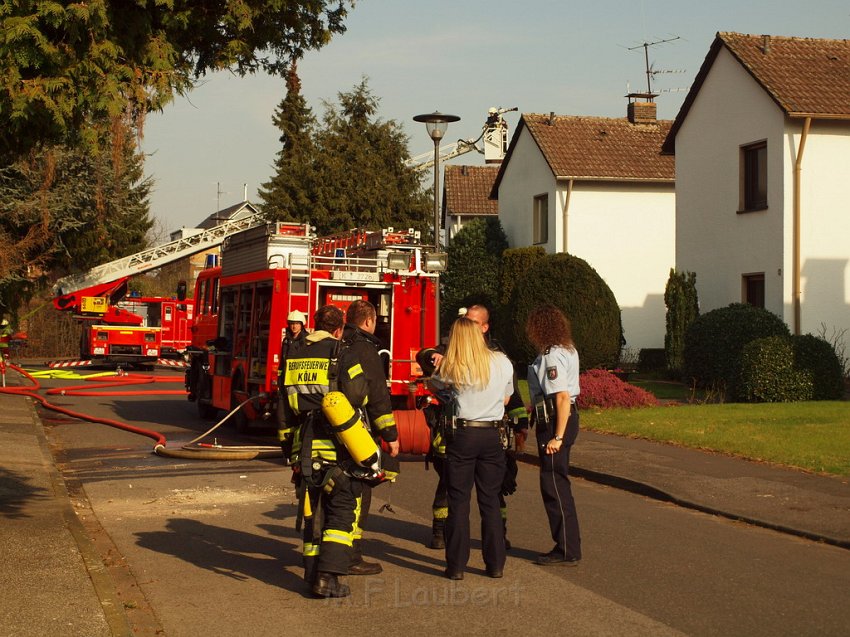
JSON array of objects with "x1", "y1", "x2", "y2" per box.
[{"x1": 416, "y1": 305, "x2": 528, "y2": 549}]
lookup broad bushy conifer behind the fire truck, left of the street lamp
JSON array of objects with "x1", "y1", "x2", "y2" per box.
[{"x1": 309, "y1": 78, "x2": 430, "y2": 233}]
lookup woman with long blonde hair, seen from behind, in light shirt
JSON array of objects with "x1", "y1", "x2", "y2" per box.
[{"x1": 430, "y1": 317, "x2": 514, "y2": 580}]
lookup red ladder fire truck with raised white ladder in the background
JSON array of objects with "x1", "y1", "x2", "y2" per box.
[{"x1": 50, "y1": 214, "x2": 264, "y2": 367}]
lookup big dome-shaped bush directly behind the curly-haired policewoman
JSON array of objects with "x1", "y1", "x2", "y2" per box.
[{"x1": 512, "y1": 253, "x2": 623, "y2": 369}]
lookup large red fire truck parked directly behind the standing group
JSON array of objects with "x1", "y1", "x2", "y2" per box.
[{"x1": 186, "y1": 223, "x2": 445, "y2": 430}]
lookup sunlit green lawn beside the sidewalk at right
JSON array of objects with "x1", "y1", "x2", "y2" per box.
[{"x1": 581, "y1": 401, "x2": 850, "y2": 476}]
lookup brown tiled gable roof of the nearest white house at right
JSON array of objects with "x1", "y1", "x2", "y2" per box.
[{"x1": 664, "y1": 31, "x2": 850, "y2": 153}]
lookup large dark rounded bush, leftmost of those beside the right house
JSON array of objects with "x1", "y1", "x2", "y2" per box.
[{"x1": 684, "y1": 303, "x2": 790, "y2": 400}]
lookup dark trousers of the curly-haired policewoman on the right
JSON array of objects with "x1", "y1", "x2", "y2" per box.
[{"x1": 537, "y1": 405, "x2": 581, "y2": 559}]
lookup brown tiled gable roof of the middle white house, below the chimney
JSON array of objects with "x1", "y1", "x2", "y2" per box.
[{"x1": 493, "y1": 113, "x2": 675, "y2": 193}]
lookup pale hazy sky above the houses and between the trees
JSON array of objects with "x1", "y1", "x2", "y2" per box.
[{"x1": 142, "y1": 0, "x2": 850, "y2": 233}]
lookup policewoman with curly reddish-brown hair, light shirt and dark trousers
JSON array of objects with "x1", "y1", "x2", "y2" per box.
[{"x1": 526, "y1": 305, "x2": 581, "y2": 566}]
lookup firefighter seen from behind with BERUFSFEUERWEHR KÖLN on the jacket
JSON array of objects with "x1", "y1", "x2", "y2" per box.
[{"x1": 281, "y1": 305, "x2": 380, "y2": 597}]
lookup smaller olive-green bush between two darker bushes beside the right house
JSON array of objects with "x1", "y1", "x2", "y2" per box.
[{"x1": 738, "y1": 336, "x2": 813, "y2": 403}]
